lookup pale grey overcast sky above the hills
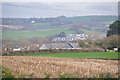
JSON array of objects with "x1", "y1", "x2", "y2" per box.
[{"x1": 2, "y1": 2, "x2": 118, "y2": 17}]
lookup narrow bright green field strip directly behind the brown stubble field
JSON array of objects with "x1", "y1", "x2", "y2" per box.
[{"x1": 23, "y1": 52, "x2": 119, "y2": 59}]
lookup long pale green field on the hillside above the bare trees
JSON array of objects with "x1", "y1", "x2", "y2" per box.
[{"x1": 2, "y1": 28, "x2": 75, "y2": 40}]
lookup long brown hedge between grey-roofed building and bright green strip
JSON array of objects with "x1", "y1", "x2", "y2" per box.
[{"x1": 2, "y1": 48, "x2": 105, "y2": 55}]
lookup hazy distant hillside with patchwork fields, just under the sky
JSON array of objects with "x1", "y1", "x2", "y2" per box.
[{"x1": 2, "y1": 16, "x2": 117, "y2": 37}]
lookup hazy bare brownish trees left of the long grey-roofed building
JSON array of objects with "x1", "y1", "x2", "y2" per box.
[{"x1": 1, "y1": 37, "x2": 50, "y2": 52}]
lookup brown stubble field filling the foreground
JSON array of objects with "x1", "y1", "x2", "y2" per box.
[{"x1": 2, "y1": 56, "x2": 118, "y2": 78}]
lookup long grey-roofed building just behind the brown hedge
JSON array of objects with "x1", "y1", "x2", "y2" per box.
[{"x1": 39, "y1": 42, "x2": 80, "y2": 49}]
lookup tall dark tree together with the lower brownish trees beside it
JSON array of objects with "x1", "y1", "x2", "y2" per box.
[{"x1": 77, "y1": 21, "x2": 120, "y2": 50}]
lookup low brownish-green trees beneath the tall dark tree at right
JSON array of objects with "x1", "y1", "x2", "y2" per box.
[{"x1": 76, "y1": 35, "x2": 120, "y2": 49}]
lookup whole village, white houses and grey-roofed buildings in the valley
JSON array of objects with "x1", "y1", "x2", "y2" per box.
[{"x1": 2, "y1": 32, "x2": 105, "y2": 51}]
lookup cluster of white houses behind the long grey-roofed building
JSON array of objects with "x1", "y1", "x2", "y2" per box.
[{"x1": 51, "y1": 34, "x2": 105, "y2": 42}]
